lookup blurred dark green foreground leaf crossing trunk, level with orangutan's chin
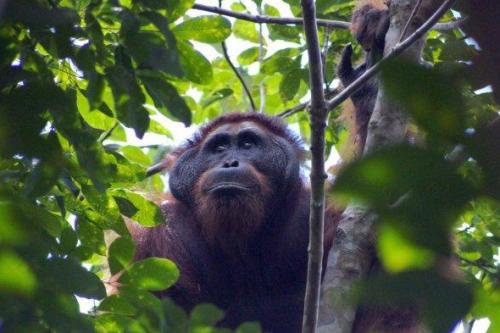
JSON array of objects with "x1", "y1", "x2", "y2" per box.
[{"x1": 334, "y1": 145, "x2": 473, "y2": 207}]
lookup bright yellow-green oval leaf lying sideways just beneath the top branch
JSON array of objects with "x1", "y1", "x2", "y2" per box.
[{"x1": 173, "y1": 15, "x2": 231, "y2": 44}]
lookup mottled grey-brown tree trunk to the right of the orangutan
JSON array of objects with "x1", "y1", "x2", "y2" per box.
[{"x1": 319, "y1": 0, "x2": 451, "y2": 333}]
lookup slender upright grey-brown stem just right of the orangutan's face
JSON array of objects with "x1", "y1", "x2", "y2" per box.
[{"x1": 301, "y1": 0, "x2": 328, "y2": 333}]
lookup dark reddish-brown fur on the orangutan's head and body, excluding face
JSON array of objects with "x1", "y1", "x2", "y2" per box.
[{"x1": 134, "y1": 113, "x2": 339, "y2": 333}]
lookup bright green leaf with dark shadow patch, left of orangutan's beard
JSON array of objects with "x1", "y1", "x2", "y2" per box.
[{"x1": 112, "y1": 190, "x2": 165, "y2": 227}]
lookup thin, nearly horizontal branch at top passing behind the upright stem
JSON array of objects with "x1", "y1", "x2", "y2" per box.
[{"x1": 193, "y1": 3, "x2": 350, "y2": 29}]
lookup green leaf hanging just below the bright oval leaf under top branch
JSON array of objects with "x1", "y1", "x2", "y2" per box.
[{"x1": 177, "y1": 42, "x2": 213, "y2": 84}]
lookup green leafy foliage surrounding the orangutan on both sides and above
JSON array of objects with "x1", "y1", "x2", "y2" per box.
[{"x1": 0, "y1": 0, "x2": 500, "y2": 332}]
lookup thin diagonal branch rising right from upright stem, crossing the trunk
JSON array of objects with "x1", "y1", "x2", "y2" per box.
[{"x1": 328, "y1": 0, "x2": 455, "y2": 110}]
